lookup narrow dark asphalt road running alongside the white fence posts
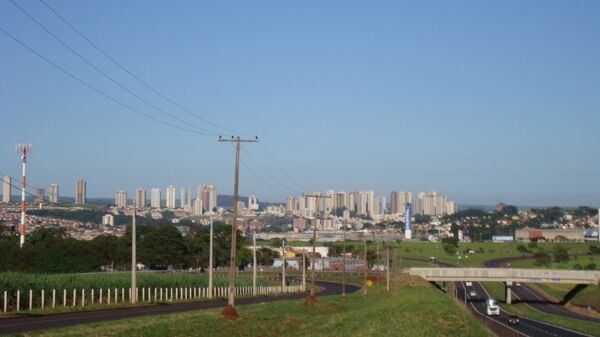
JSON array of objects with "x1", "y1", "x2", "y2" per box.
[{"x1": 0, "y1": 282, "x2": 360, "y2": 335}]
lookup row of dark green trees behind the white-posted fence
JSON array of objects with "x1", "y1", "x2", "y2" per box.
[{"x1": 0, "y1": 223, "x2": 277, "y2": 273}]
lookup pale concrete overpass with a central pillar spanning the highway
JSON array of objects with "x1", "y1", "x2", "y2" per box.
[{"x1": 409, "y1": 268, "x2": 600, "y2": 304}]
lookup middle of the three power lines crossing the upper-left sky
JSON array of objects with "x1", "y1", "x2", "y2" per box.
[{"x1": 9, "y1": 0, "x2": 218, "y2": 136}]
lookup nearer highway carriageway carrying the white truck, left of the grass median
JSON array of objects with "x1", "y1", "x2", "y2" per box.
[{"x1": 456, "y1": 282, "x2": 589, "y2": 337}]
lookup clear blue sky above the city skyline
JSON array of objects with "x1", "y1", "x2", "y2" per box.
[{"x1": 0, "y1": 0, "x2": 600, "y2": 206}]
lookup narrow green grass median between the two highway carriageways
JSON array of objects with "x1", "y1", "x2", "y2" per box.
[{"x1": 479, "y1": 282, "x2": 600, "y2": 336}]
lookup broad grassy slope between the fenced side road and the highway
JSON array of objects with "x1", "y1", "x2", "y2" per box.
[{"x1": 15, "y1": 276, "x2": 491, "y2": 337}]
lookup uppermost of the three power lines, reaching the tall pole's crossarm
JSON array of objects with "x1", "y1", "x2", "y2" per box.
[{"x1": 37, "y1": 0, "x2": 253, "y2": 136}]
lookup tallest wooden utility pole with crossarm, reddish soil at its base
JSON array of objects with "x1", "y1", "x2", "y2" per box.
[{"x1": 219, "y1": 136, "x2": 258, "y2": 319}]
